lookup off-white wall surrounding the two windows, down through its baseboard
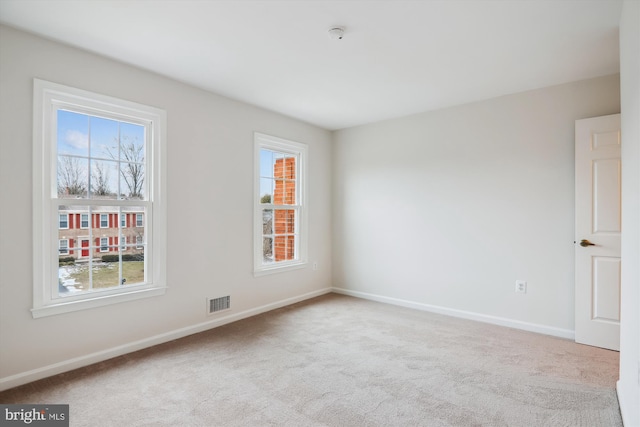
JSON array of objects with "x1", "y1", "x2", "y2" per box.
[{"x1": 0, "y1": 27, "x2": 331, "y2": 389}]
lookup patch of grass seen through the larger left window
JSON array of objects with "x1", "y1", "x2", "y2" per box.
[{"x1": 70, "y1": 261, "x2": 144, "y2": 289}]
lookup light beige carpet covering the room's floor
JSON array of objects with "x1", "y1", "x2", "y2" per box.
[{"x1": 0, "y1": 294, "x2": 622, "y2": 427}]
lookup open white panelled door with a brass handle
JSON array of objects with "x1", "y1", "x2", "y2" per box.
[{"x1": 575, "y1": 114, "x2": 622, "y2": 350}]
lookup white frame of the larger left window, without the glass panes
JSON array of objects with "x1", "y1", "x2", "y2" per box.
[{"x1": 31, "y1": 79, "x2": 167, "y2": 318}]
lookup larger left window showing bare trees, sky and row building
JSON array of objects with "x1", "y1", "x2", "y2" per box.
[{"x1": 32, "y1": 80, "x2": 166, "y2": 317}]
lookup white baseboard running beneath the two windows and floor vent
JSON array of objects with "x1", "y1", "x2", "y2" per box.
[{"x1": 0, "y1": 288, "x2": 331, "y2": 391}]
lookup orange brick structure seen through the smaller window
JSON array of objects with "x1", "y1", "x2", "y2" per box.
[{"x1": 272, "y1": 157, "x2": 296, "y2": 262}]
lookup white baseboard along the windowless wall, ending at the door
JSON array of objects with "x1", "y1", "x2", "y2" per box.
[{"x1": 331, "y1": 288, "x2": 575, "y2": 340}]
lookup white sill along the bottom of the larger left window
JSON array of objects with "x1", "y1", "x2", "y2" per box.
[{"x1": 31, "y1": 287, "x2": 167, "y2": 319}]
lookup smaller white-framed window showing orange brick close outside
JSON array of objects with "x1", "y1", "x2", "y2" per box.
[{"x1": 254, "y1": 133, "x2": 307, "y2": 274}]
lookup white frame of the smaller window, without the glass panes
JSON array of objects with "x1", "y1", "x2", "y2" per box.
[{"x1": 253, "y1": 132, "x2": 308, "y2": 276}]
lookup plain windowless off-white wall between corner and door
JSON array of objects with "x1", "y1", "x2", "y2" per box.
[{"x1": 333, "y1": 75, "x2": 620, "y2": 337}]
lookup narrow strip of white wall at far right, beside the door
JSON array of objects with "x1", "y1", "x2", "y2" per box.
[{"x1": 618, "y1": 0, "x2": 640, "y2": 426}]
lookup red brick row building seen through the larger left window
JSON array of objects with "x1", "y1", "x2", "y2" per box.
[{"x1": 58, "y1": 210, "x2": 144, "y2": 260}]
